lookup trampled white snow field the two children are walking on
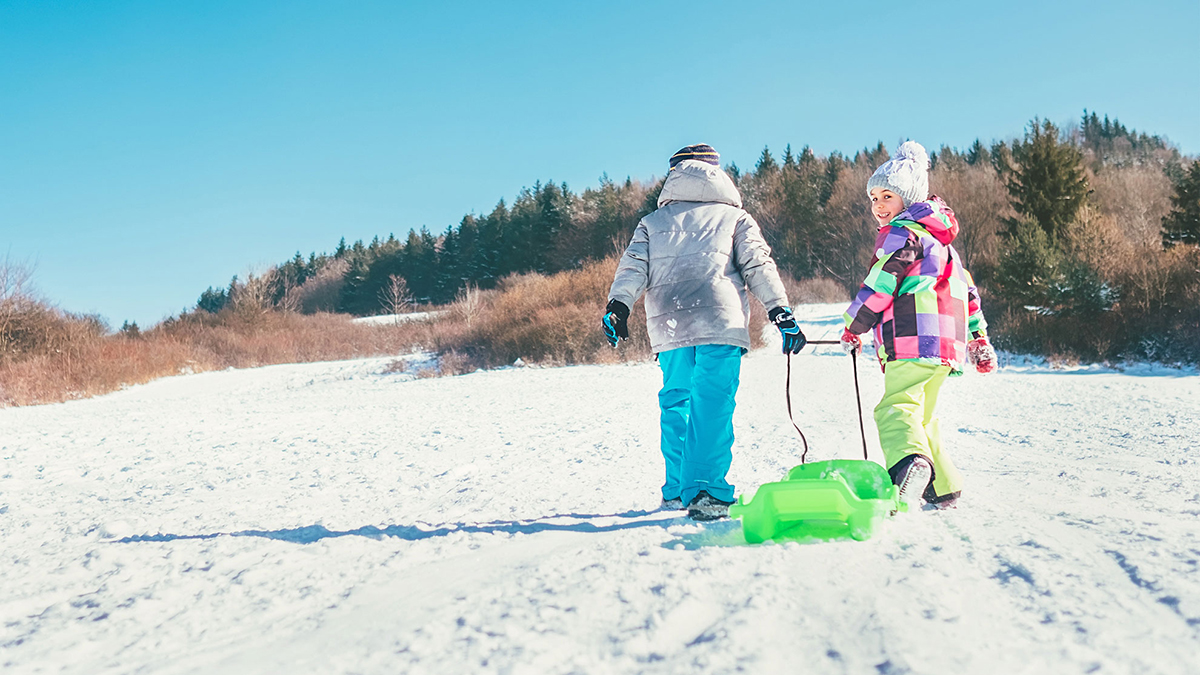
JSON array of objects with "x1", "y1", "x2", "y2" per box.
[{"x1": 0, "y1": 307, "x2": 1200, "y2": 675}]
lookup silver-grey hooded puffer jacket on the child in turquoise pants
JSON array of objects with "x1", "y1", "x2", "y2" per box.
[{"x1": 608, "y1": 160, "x2": 787, "y2": 353}]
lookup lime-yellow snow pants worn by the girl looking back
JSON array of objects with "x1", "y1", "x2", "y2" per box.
[{"x1": 875, "y1": 360, "x2": 962, "y2": 501}]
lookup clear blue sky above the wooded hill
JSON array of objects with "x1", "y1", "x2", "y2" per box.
[{"x1": 0, "y1": 0, "x2": 1200, "y2": 327}]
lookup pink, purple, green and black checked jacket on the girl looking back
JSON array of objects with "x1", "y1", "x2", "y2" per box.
[{"x1": 844, "y1": 197, "x2": 988, "y2": 375}]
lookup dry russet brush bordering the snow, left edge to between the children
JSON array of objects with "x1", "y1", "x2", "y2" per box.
[{"x1": 0, "y1": 258, "x2": 846, "y2": 406}]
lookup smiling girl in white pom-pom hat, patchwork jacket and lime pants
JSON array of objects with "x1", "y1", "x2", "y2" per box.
[{"x1": 841, "y1": 141, "x2": 996, "y2": 507}]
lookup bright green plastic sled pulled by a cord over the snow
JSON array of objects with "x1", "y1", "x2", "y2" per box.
[{"x1": 730, "y1": 459, "x2": 907, "y2": 544}]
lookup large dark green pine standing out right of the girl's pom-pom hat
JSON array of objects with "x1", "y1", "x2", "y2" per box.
[{"x1": 1007, "y1": 119, "x2": 1088, "y2": 240}]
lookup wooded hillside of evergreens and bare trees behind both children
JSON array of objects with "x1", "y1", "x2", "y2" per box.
[{"x1": 197, "y1": 112, "x2": 1200, "y2": 360}]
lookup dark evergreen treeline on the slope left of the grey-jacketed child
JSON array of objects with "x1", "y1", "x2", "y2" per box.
[{"x1": 197, "y1": 177, "x2": 661, "y2": 316}]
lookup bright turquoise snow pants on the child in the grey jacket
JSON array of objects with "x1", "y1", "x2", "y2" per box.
[{"x1": 659, "y1": 345, "x2": 742, "y2": 504}]
